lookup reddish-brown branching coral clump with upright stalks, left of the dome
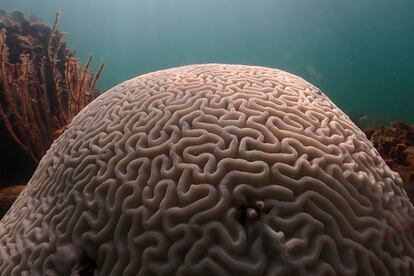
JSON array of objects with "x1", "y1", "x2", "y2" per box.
[{"x1": 0, "y1": 12, "x2": 103, "y2": 163}]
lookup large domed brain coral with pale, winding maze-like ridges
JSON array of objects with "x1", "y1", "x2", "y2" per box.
[{"x1": 0, "y1": 64, "x2": 414, "y2": 275}]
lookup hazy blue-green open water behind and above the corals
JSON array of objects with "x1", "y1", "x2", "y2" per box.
[{"x1": 0, "y1": 0, "x2": 414, "y2": 122}]
